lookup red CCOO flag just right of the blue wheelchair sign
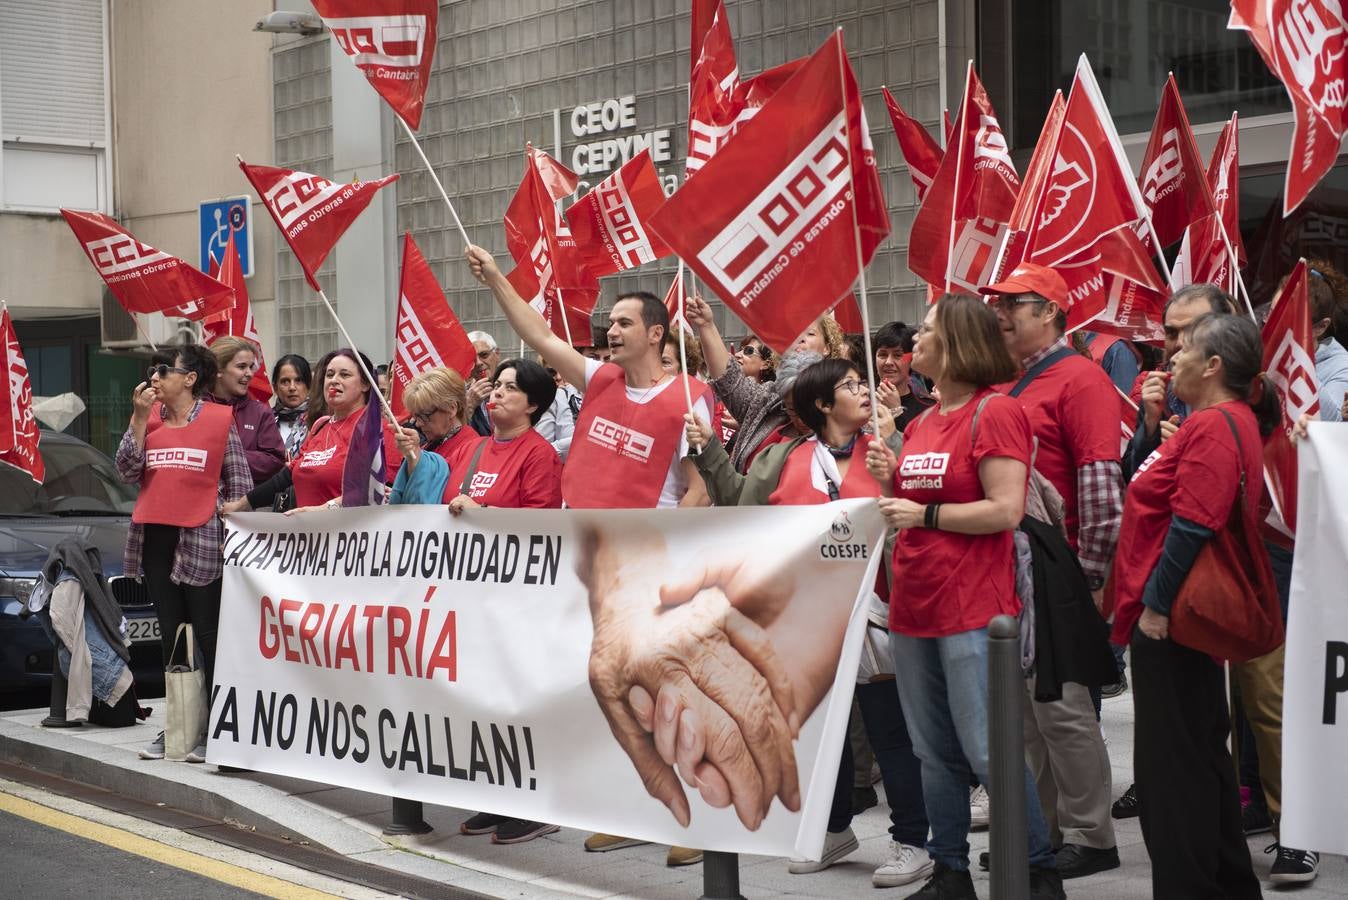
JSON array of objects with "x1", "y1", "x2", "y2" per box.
[{"x1": 239, "y1": 159, "x2": 398, "y2": 291}]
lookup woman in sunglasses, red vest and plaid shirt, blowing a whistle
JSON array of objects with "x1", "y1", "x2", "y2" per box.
[{"x1": 116, "y1": 345, "x2": 252, "y2": 763}]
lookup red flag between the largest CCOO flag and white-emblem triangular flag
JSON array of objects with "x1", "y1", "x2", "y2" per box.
[{"x1": 909, "y1": 63, "x2": 1020, "y2": 294}]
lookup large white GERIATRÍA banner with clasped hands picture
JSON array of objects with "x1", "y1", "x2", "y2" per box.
[{"x1": 209, "y1": 500, "x2": 883, "y2": 858}]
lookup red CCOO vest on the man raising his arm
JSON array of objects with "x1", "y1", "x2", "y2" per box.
[{"x1": 562, "y1": 362, "x2": 706, "y2": 509}]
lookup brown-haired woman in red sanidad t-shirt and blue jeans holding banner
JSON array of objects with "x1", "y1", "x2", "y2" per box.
[{"x1": 867, "y1": 295, "x2": 1062, "y2": 896}]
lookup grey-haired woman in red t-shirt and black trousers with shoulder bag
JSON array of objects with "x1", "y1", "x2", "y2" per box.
[{"x1": 1113, "y1": 314, "x2": 1281, "y2": 900}]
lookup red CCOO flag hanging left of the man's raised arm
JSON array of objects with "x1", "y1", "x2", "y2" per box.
[{"x1": 388, "y1": 232, "x2": 477, "y2": 422}]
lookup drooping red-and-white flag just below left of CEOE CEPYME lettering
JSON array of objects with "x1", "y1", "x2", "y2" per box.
[{"x1": 506, "y1": 146, "x2": 599, "y2": 346}]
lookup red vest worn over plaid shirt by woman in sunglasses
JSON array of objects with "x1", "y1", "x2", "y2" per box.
[{"x1": 131, "y1": 403, "x2": 235, "y2": 528}]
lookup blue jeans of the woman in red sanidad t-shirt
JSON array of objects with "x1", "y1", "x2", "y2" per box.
[{"x1": 890, "y1": 628, "x2": 1055, "y2": 870}]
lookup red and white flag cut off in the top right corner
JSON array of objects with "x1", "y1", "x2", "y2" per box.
[{"x1": 1227, "y1": 0, "x2": 1348, "y2": 216}]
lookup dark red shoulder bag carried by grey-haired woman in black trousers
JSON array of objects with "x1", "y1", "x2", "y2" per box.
[{"x1": 1170, "y1": 410, "x2": 1283, "y2": 663}]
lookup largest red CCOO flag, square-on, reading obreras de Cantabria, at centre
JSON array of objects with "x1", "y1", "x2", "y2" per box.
[{"x1": 650, "y1": 32, "x2": 890, "y2": 352}]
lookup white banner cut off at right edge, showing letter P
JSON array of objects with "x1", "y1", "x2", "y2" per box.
[{"x1": 1282, "y1": 422, "x2": 1348, "y2": 853}]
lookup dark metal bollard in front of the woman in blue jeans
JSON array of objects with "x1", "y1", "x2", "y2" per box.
[{"x1": 988, "y1": 616, "x2": 1038, "y2": 900}]
